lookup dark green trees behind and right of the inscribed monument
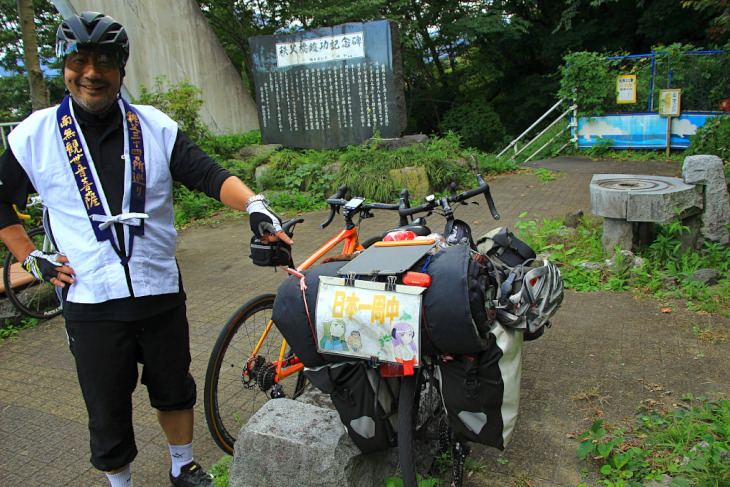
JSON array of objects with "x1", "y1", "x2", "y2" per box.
[{"x1": 199, "y1": 0, "x2": 727, "y2": 149}]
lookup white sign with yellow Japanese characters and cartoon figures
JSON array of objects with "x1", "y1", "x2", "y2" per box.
[{"x1": 315, "y1": 276, "x2": 425, "y2": 367}]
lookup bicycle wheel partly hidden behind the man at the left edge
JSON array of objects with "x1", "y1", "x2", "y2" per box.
[{"x1": 3, "y1": 226, "x2": 62, "y2": 320}]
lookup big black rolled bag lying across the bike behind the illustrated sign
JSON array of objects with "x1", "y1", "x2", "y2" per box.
[{"x1": 272, "y1": 244, "x2": 495, "y2": 367}]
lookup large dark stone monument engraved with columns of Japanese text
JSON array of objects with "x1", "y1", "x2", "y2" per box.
[{"x1": 250, "y1": 20, "x2": 406, "y2": 149}]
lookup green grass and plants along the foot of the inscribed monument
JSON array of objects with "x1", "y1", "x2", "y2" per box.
[{"x1": 168, "y1": 134, "x2": 520, "y2": 228}]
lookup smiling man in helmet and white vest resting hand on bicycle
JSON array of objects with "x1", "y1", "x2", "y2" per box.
[{"x1": 0, "y1": 12, "x2": 292, "y2": 487}]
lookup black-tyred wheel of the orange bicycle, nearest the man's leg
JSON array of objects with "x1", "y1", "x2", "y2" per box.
[{"x1": 203, "y1": 294, "x2": 306, "y2": 454}]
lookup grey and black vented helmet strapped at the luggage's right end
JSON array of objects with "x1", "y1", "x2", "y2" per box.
[{"x1": 497, "y1": 260, "x2": 563, "y2": 332}]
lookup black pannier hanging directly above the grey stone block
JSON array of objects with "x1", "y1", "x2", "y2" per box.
[{"x1": 304, "y1": 361, "x2": 398, "y2": 453}]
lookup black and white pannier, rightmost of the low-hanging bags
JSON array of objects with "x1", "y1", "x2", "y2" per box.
[{"x1": 436, "y1": 322, "x2": 522, "y2": 450}]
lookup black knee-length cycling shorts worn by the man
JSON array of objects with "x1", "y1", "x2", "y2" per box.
[{"x1": 66, "y1": 304, "x2": 196, "y2": 471}]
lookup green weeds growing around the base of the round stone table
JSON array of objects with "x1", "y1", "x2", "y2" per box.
[{"x1": 515, "y1": 213, "x2": 730, "y2": 316}]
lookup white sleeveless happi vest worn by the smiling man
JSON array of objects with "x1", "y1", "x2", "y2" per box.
[{"x1": 8, "y1": 100, "x2": 179, "y2": 303}]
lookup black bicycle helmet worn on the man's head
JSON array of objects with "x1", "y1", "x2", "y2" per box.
[{"x1": 56, "y1": 12, "x2": 129, "y2": 74}]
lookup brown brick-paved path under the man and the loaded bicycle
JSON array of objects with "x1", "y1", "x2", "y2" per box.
[{"x1": 0, "y1": 158, "x2": 730, "y2": 487}]
